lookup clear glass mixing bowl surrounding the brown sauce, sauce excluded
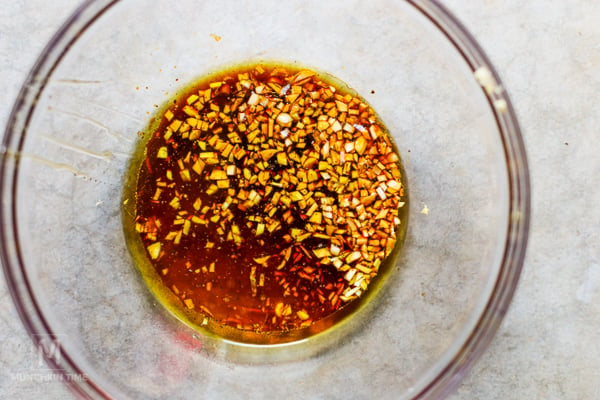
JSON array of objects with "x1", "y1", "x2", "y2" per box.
[{"x1": 0, "y1": 0, "x2": 529, "y2": 399}]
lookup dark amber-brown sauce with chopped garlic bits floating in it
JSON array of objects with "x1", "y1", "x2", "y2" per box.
[{"x1": 127, "y1": 65, "x2": 405, "y2": 340}]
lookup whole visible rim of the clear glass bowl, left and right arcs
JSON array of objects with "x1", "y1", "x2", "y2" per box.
[{"x1": 0, "y1": 0, "x2": 531, "y2": 399}]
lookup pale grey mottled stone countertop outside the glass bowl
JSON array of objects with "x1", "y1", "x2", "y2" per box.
[{"x1": 0, "y1": 0, "x2": 600, "y2": 400}]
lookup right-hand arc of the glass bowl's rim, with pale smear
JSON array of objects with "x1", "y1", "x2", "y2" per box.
[{"x1": 408, "y1": 0, "x2": 531, "y2": 399}]
